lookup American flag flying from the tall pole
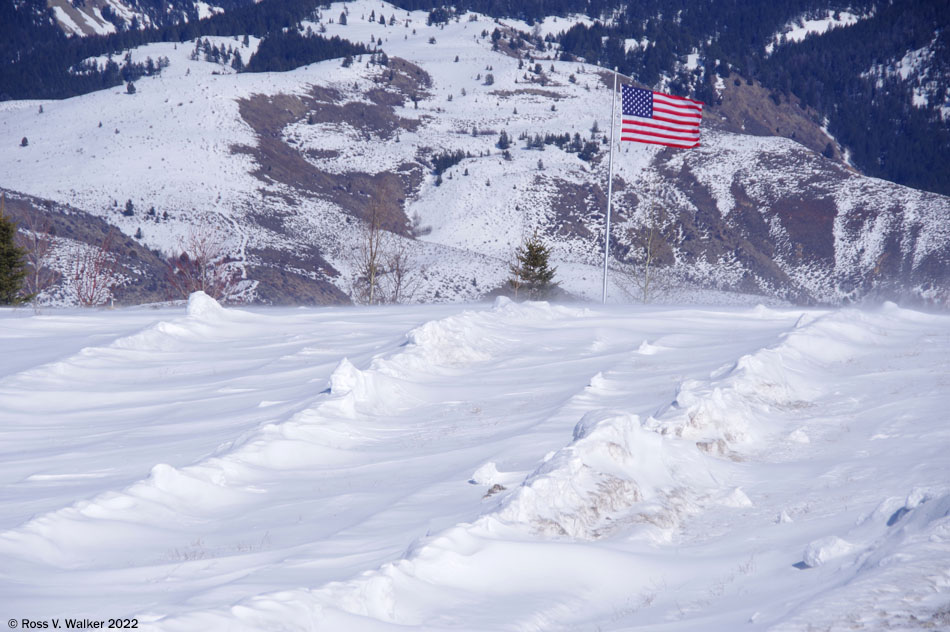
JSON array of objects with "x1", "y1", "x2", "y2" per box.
[{"x1": 620, "y1": 86, "x2": 703, "y2": 149}]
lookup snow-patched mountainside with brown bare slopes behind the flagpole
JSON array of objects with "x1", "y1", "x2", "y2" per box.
[{"x1": 0, "y1": 1, "x2": 950, "y2": 303}]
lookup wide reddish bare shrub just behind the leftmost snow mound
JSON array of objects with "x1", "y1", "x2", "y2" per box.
[{"x1": 167, "y1": 229, "x2": 241, "y2": 301}]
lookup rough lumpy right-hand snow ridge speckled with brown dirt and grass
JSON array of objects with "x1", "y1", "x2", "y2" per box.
[{"x1": 496, "y1": 304, "x2": 884, "y2": 539}]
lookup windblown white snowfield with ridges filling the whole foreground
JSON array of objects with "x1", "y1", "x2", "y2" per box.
[{"x1": 0, "y1": 295, "x2": 950, "y2": 631}]
